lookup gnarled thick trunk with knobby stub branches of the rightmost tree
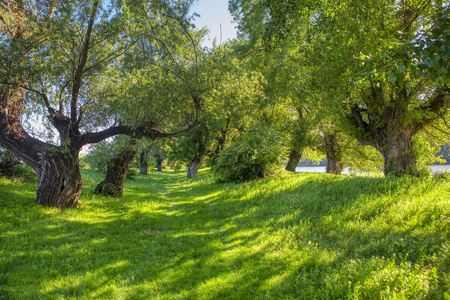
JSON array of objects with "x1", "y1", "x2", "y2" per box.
[{"x1": 347, "y1": 82, "x2": 450, "y2": 176}]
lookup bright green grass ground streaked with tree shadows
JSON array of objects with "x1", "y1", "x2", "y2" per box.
[{"x1": 0, "y1": 170, "x2": 450, "y2": 299}]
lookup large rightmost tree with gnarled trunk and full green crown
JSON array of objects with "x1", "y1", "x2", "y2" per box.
[{"x1": 265, "y1": 0, "x2": 450, "y2": 175}]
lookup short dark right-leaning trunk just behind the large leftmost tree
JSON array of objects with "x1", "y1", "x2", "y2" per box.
[{"x1": 94, "y1": 149, "x2": 136, "y2": 197}]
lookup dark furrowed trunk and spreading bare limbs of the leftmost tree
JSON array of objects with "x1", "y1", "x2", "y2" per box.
[{"x1": 0, "y1": 1, "x2": 201, "y2": 208}]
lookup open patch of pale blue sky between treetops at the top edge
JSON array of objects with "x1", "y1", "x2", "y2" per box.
[{"x1": 193, "y1": 0, "x2": 236, "y2": 47}]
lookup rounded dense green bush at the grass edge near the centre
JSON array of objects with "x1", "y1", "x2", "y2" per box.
[{"x1": 214, "y1": 125, "x2": 284, "y2": 182}]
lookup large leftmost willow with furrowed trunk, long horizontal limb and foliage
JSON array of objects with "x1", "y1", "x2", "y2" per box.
[{"x1": 0, "y1": 0, "x2": 204, "y2": 208}]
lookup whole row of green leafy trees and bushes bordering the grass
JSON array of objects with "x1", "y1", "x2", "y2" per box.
[{"x1": 0, "y1": 0, "x2": 450, "y2": 208}]
